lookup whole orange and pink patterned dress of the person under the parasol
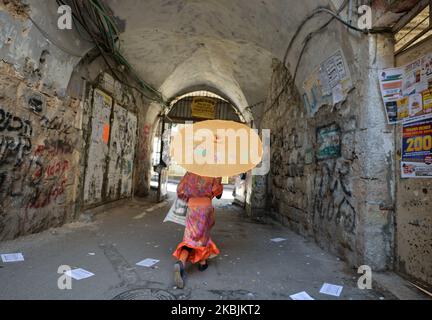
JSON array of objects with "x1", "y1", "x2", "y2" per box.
[{"x1": 173, "y1": 172, "x2": 223, "y2": 263}]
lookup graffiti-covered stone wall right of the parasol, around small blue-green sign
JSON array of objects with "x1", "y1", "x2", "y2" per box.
[{"x1": 263, "y1": 60, "x2": 360, "y2": 261}]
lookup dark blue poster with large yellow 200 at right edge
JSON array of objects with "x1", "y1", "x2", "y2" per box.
[{"x1": 401, "y1": 119, "x2": 432, "y2": 178}]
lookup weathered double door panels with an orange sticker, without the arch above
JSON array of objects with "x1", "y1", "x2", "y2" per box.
[{"x1": 84, "y1": 89, "x2": 137, "y2": 205}]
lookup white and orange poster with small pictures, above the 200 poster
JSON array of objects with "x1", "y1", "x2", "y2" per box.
[{"x1": 379, "y1": 54, "x2": 432, "y2": 124}]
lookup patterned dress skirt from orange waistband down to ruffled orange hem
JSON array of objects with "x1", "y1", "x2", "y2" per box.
[{"x1": 173, "y1": 198, "x2": 220, "y2": 263}]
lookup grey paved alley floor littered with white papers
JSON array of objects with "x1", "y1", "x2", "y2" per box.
[{"x1": 0, "y1": 188, "x2": 395, "y2": 300}]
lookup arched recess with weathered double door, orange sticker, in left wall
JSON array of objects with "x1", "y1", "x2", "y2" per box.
[{"x1": 83, "y1": 72, "x2": 141, "y2": 206}]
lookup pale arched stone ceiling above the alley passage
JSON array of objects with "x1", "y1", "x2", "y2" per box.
[{"x1": 104, "y1": 0, "x2": 334, "y2": 109}]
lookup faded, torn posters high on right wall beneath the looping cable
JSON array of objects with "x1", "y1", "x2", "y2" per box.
[{"x1": 303, "y1": 50, "x2": 353, "y2": 116}]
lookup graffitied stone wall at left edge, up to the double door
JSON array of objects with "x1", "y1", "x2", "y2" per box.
[{"x1": 0, "y1": 2, "x2": 87, "y2": 240}]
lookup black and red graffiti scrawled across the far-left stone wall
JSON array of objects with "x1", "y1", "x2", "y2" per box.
[{"x1": 0, "y1": 93, "x2": 79, "y2": 240}]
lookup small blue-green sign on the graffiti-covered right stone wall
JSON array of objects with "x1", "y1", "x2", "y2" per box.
[{"x1": 316, "y1": 124, "x2": 341, "y2": 161}]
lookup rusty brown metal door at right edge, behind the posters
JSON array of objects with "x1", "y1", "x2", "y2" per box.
[{"x1": 396, "y1": 40, "x2": 432, "y2": 287}]
